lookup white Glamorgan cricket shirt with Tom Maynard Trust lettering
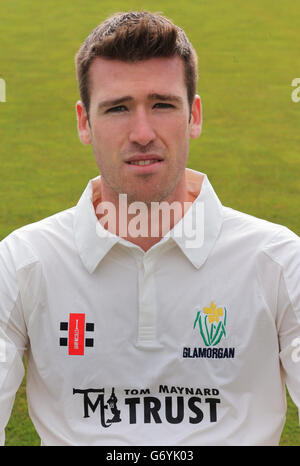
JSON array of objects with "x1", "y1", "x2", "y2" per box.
[{"x1": 0, "y1": 169, "x2": 300, "y2": 446}]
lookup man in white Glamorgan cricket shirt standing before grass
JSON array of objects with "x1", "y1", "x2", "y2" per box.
[{"x1": 0, "y1": 12, "x2": 300, "y2": 445}]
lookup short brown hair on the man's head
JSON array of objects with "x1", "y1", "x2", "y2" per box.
[{"x1": 75, "y1": 11, "x2": 198, "y2": 119}]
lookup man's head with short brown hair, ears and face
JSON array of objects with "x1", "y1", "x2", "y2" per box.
[{"x1": 76, "y1": 12, "x2": 201, "y2": 203}]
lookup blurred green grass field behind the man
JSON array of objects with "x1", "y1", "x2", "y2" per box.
[{"x1": 0, "y1": 0, "x2": 300, "y2": 446}]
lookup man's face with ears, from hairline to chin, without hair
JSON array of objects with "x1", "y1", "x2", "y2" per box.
[{"x1": 77, "y1": 57, "x2": 201, "y2": 203}]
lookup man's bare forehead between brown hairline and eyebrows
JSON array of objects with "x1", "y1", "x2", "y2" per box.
[{"x1": 89, "y1": 56, "x2": 186, "y2": 100}]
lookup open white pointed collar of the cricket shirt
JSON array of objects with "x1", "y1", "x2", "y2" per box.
[{"x1": 74, "y1": 169, "x2": 223, "y2": 273}]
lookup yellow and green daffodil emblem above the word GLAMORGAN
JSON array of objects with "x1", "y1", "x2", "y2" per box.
[{"x1": 194, "y1": 301, "x2": 227, "y2": 346}]
